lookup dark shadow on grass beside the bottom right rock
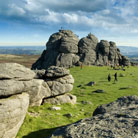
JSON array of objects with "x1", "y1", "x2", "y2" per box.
[{"x1": 22, "y1": 127, "x2": 59, "y2": 138}]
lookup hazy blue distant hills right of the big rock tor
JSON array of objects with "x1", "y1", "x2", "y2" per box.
[{"x1": 118, "y1": 46, "x2": 138, "y2": 58}]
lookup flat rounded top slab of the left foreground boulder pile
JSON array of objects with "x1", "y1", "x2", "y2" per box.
[{"x1": 0, "y1": 63, "x2": 35, "y2": 80}]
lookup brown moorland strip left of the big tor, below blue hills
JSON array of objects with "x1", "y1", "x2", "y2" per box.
[{"x1": 0, "y1": 54, "x2": 40, "y2": 68}]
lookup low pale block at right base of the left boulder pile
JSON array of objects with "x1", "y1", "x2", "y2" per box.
[{"x1": 44, "y1": 93, "x2": 77, "y2": 104}]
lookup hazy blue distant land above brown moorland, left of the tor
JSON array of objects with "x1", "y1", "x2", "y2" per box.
[{"x1": 0, "y1": 46, "x2": 46, "y2": 55}]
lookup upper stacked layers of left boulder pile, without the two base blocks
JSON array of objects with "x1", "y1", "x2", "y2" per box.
[{"x1": 0, "y1": 63, "x2": 74, "y2": 106}]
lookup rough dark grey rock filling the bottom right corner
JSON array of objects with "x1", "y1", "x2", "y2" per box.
[{"x1": 51, "y1": 96, "x2": 138, "y2": 138}]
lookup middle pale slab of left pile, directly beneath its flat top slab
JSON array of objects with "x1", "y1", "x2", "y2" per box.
[{"x1": 0, "y1": 79, "x2": 51, "y2": 106}]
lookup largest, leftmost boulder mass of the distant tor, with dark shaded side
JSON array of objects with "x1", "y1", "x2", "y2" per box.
[{"x1": 32, "y1": 30, "x2": 79, "y2": 70}]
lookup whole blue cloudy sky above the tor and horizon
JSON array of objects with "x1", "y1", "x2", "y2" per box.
[{"x1": 0, "y1": 0, "x2": 138, "y2": 47}]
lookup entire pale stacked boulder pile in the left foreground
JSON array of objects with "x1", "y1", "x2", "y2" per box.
[{"x1": 0, "y1": 63, "x2": 76, "y2": 138}]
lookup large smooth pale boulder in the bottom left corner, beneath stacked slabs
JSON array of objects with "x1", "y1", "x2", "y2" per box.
[{"x1": 0, "y1": 93, "x2": 29, "y2": 138}]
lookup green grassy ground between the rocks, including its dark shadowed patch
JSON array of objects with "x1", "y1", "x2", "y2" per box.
[{"x1": 17, "y1": 66, "x2": 138, "y2": 138}]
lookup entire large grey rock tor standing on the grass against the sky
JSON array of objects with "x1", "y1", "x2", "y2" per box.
[{"x1": 32, "y1": 30, "x2": 130, "y2": 69}]
